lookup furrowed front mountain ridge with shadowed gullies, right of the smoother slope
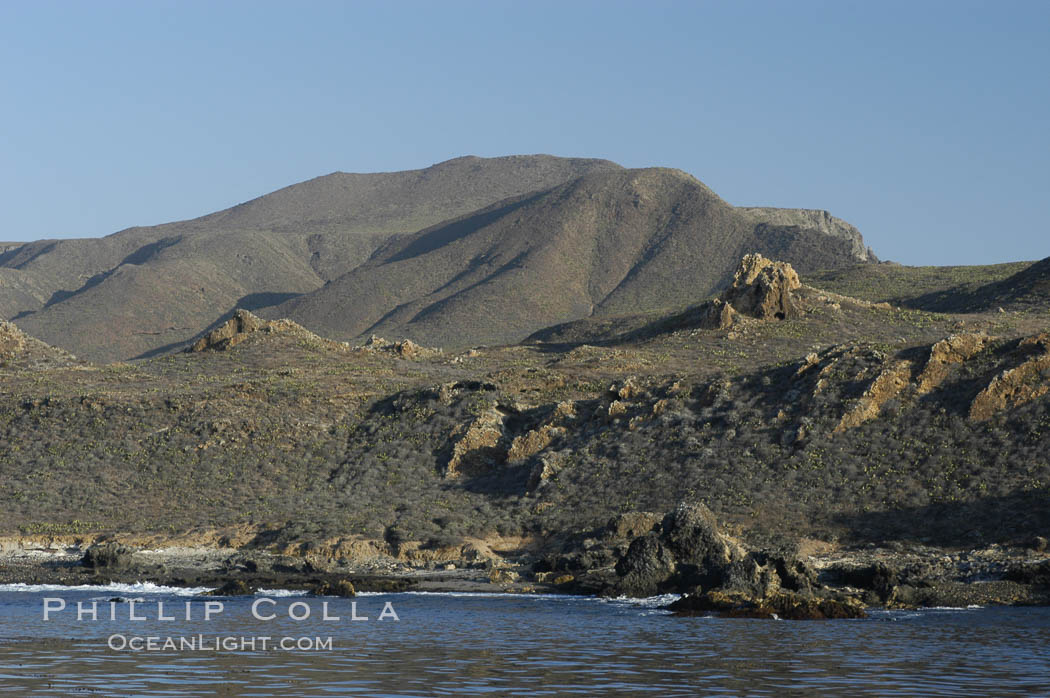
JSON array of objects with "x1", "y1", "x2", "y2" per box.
[{"x1": 265, "y1": 168, "x2": 867, "y2": 346}]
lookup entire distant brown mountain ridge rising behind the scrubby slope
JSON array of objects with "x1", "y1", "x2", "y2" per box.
[{"x1": 0, "y1": 155, "x2": 877, "y2": 362}]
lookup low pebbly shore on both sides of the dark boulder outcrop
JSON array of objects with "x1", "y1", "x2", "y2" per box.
[{"x1": 0, "y1": 540, "x2": 1050, "y2": 615}]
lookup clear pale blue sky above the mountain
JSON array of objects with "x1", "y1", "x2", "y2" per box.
[{"x1": 0, "y1": 0, "x2": 1050, "y2": 265}]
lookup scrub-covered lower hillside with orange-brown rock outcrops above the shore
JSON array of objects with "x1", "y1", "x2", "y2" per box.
[{"x1": 0, "y1": 256, "x2": 1050, "y2": 562}]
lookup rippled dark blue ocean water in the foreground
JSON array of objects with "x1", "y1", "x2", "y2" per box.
[{"x1": 0, "y1": 585, "x2": 1050, "y2": 697}]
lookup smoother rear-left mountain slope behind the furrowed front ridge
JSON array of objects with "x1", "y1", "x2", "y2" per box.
[{"x1": 0, "y1": 155, "x2": 618, "y2": 361}]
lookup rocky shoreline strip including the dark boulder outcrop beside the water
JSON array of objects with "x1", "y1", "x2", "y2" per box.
[{"x1": 0, "y1": 504, "x2": 1050, "y2": 619}]
